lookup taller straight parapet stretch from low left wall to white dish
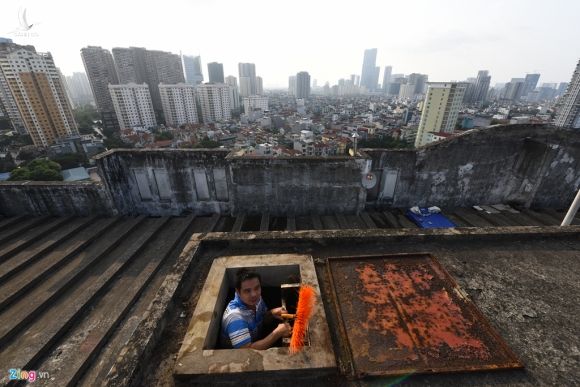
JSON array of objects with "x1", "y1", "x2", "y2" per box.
[{"x1": 97, "y1": 149, "x2": 370, "y2": 215}]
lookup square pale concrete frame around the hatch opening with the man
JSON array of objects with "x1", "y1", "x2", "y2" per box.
[{"x1": 174, "y1": 254, "x2": 336, "y2": 383}]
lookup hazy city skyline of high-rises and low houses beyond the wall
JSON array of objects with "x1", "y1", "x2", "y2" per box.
[{"x1": 0, "y1": 39, "x2": 580, "y2": 162}]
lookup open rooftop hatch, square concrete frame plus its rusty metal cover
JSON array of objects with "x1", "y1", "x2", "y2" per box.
[{"x1": 174, "y1": 254, "x2": 522, "y2": 381}]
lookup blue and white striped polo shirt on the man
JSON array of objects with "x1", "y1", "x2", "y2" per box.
[{"x1": 221, "y1": 292, "x2": 268, "y2": 348}]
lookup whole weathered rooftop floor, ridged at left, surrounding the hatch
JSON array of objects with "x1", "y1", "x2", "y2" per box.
[{"x1": 0, "y1": 208, "x2": 580, "y2": 386}]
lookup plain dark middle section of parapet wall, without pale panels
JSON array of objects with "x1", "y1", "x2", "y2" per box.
[{"x1": 228, "y1": 157, "x2": 367, "y2": 216}]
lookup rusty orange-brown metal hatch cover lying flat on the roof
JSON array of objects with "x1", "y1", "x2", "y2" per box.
[{"x1": 328, "y1": 254, "x2": 523, "y2": 377}]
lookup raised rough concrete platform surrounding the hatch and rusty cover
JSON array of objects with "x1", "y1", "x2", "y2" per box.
[{"x1": 134, "y1": 226, "x2": 580, "y2": 386}]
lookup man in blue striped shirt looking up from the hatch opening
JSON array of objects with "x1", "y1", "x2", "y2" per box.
[{"x1": 220, "y1": 269, "x2": 292, "y2": 349}]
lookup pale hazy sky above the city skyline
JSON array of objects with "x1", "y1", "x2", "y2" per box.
[{"x1": 0, "y1": 0, "x2": 580, "y2": 87}]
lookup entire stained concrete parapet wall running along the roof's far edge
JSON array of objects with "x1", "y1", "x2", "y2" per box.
[{"x1": 0, "y1": 125, "x2": 580, "y2": 216}]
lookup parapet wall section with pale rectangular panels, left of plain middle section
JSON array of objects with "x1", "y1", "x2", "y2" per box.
[{"x1": 96, "y1": 149, "x2": 231, "y2": 215}]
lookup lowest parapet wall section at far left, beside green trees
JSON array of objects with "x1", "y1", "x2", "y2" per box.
[{"x1": 0, "y1": 181, "x2": 117, "y2": 216}]
